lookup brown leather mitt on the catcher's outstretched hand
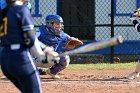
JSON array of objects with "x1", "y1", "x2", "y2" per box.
[{"x1": 65, "y1": 37, "x2": 83, "y2": 50}]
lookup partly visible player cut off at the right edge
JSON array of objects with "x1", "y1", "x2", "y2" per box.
[{"x1": 127, "y1": 9, "x2": 140, "y2": 79}]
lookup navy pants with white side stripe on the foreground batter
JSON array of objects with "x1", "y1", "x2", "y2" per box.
[{"x1": 2, "y1": 49, "x2": 42, "y2": 93}]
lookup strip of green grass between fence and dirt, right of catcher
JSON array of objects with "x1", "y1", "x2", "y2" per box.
[{"x1": 67, "y1": 62, "x2": 136, "y2": 70}]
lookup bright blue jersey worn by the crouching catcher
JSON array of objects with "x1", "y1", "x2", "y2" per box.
[{"x1": 36, "y1": 24, "x2": 70, "y2": 54}]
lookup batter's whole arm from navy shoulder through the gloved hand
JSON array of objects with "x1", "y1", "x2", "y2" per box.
[{"x1": 20, "y1": 7, "x2": 58, "y2": 63}]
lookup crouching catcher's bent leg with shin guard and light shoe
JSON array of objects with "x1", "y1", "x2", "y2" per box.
[{"x1": 47, "y1": 56, "x2": 70, "y2": 79}]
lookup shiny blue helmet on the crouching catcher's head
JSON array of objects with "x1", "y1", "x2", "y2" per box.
[{"x1": 45, "y1": 15, "x2": 63, "y2": 26}]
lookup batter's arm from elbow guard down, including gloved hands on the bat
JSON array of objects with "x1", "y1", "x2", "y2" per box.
[{"x1": 24, "y1": 27, "x2": 60, "y2": 67}]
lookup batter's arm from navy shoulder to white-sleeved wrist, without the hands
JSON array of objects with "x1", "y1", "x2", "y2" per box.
[{"x1": 18, "y1": 6, "x2": 45, "y2": 61}]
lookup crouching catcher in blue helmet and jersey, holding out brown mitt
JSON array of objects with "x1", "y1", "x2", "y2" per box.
[{"x1": 36, "y1": 15, "x2": 83, "y2": 79}]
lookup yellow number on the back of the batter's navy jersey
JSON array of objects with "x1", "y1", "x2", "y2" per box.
[{"x1": 0, "y1": 17, "x2": 8, "y2": 37}]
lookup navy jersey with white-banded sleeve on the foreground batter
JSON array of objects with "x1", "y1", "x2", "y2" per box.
[{"x1": 0, "y1": 5, "x2": 34, "y2": 46}]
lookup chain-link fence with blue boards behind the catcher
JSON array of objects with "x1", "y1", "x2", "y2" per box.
[{"x1": 31, "y1": 0, "x2": 140, "y2": 63}]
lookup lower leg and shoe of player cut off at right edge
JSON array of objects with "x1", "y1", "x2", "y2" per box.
[{"x1": 127, "y1": 60, "x2": 140, "y2": 79}]
